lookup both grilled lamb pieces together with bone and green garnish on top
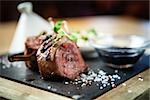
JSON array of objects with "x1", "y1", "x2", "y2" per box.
[{"x1": 9, "y1": 21, "x2": 87, "y2": 80}]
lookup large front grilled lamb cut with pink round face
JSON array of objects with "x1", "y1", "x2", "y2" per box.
[{"x1": 37, "y1": 36, "x2": 87, "y2": 79}]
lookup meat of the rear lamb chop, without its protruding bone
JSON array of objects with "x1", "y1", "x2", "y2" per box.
[{"x1": 24, "y1": 33, "x2": 54, "y2": 70}]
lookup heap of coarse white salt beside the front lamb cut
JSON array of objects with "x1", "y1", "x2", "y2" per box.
[{"x1": 65, "y1": 69, "x2": 121, "y2": 89}]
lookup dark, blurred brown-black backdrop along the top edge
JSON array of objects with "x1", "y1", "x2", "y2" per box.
[{"x1": 0, "y1": 0, "x2": 149, "y2": 22}]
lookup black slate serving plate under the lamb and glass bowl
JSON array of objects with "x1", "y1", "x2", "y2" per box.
[{"x1": 0, "y1": 55, "x2": 150, "y2": 100}]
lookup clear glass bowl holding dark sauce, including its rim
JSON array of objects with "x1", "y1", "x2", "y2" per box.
[{"x1": 89, "y1": 35, "x2": 149, "y2": 68}]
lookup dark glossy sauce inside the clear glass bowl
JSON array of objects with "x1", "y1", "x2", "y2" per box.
[{"x1": 95, "y1": 47, "x2": 145, "y2": 67}]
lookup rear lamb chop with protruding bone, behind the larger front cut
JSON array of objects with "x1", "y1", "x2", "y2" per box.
[{"x1": 8, "y1": 33, "x2": 51, "y2": 70}]
